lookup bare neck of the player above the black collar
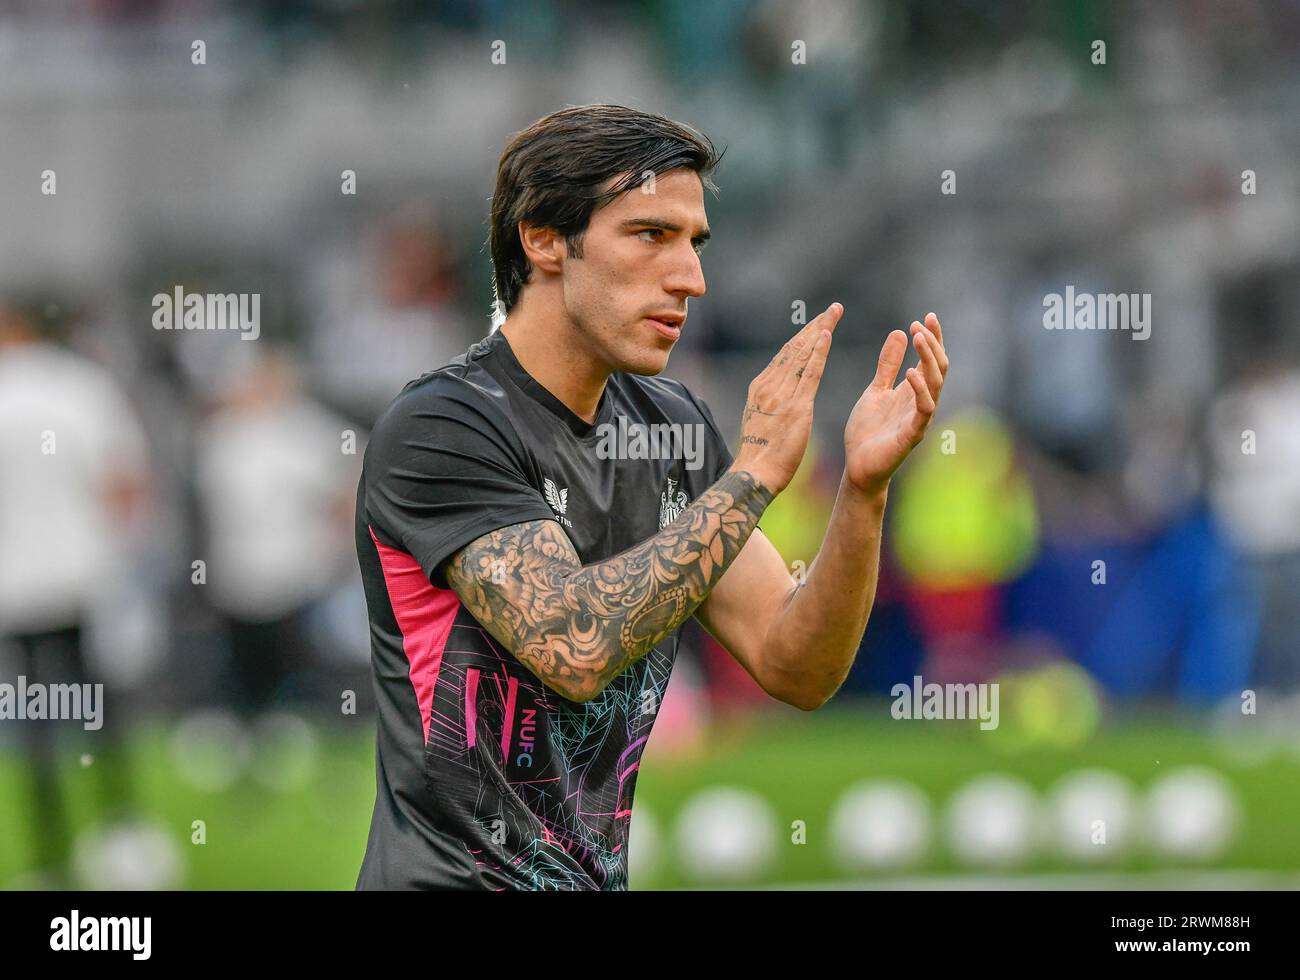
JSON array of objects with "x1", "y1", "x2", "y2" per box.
[{"x1": 501, "y1": 302, "x2": 610, "y2": 422}]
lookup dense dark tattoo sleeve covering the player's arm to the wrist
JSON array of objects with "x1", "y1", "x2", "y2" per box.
[{"x1": 447, "y1": 471, "x2": 772, "y2": 701}]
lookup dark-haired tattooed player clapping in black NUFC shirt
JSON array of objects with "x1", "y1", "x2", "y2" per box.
[{"x1": 356, "y1": 105, "x2": 948, "y2": 889}]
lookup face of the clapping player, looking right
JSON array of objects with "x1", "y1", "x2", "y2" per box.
[{"x1": 563, "y1": 169, "x2": 709, "y2": 374}]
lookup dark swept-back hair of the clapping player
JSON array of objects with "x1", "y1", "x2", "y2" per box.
[{"x1": 488, "y1": 105, "x2": 725, "y2": 313}]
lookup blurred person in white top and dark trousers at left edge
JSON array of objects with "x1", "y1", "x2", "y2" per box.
[{"x1": 0, "y1": 299, "x2": 148, "y2": 884}]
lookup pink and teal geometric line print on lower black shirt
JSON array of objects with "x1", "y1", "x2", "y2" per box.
[{"x1": 425, "y1": 615, "x2": 677, "y2": 889}]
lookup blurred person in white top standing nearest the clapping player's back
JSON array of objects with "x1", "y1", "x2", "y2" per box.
[{"x1": 196, "y1": 350, "x2": 361, "y2": 715}]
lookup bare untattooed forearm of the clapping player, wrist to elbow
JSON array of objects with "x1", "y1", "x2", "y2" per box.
[{"x1": 762, "y1": 470, "x2": 888, "y2": 708}]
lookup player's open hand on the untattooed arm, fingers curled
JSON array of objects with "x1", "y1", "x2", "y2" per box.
[{"x1": 844, "y1": 313, "x2": 948, "y2": 493}]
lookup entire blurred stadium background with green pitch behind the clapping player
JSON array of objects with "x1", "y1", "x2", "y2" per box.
[{"x1": 0, "y1": 0, "x2": 1300, "y2": 889}]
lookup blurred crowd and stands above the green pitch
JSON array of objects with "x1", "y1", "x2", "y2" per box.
[{"x1": 0, "y1": 0, "x2": 1300, "y2": 878}]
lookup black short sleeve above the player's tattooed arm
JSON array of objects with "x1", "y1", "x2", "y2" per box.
[{"x1": 361, "y1": 378, "x2": 554, "y2": 589}]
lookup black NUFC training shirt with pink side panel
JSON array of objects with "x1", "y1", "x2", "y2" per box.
[{"x1": 356, "y1": 331, "x2": 732, "y2": 889}]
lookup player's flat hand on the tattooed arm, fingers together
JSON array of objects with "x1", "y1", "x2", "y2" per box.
[{"x1": 732, "y1": 303, "x2": 844, "y2": 495}]
